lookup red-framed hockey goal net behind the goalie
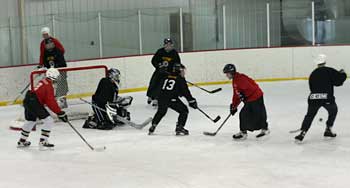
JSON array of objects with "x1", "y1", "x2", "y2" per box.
[{"x1": 10, "y1": 65, "x2": 108, "y2": 130}]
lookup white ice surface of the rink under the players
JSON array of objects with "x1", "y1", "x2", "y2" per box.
[{"x1": 0, "y1": 81, "x2": 350, "y2": 188}]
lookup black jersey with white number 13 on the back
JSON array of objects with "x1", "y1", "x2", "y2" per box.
[{"x1": 158, "y1": 75, "x2": 194, "y2": 101}]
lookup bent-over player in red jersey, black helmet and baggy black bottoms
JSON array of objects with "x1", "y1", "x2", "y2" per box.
[{"x1": 223, "y1": 64, "x2": 270, "y2": 140}]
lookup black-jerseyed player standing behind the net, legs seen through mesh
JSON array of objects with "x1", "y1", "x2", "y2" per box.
[{"x1": 42, "y1": 38, "x2": 68, "y2": 108}]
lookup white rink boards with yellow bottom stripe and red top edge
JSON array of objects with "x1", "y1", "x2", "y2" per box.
[{"x1": 0, "y1": 46, "x2": 350, "y2": 105}]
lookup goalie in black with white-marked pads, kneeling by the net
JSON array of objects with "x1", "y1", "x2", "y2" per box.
[{"x1": 83, "y1": 68, "x2": 133, "y2": 130}]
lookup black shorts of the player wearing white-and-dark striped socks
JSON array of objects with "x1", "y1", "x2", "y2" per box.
[{"x1": 23, "y1": 91, "x2": 50, "y2": 121}]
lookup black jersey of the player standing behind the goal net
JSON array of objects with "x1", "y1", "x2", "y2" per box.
[{"x1": 44, "y1": 48, "x2": 67, "y2": 68}]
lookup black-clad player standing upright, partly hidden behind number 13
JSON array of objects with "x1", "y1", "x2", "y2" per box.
[{"x1": 147, "y1": 38, "x2": 181, "y2": 106}]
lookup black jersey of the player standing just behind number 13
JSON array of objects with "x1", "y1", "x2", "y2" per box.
[{"x1": 152, "y1": 48, "x2": 181, "y2": 72}]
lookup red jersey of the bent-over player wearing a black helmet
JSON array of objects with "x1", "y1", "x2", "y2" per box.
[{"x1": 232, "y1": 72, "x2": 264, "y2": 108}]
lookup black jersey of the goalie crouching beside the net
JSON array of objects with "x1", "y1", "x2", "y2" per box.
[{"x1": 92, "y1": 77, "x2": 119, "y2": 106}]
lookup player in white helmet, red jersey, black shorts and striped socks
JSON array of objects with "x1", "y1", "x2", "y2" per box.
[{"x1": 17, "y1": 68, "x2": 68, "y2": 148}]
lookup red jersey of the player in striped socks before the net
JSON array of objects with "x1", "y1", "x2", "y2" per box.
[{"x1": 32, "y1": 78, "x2": 62, "y2": 114}]
